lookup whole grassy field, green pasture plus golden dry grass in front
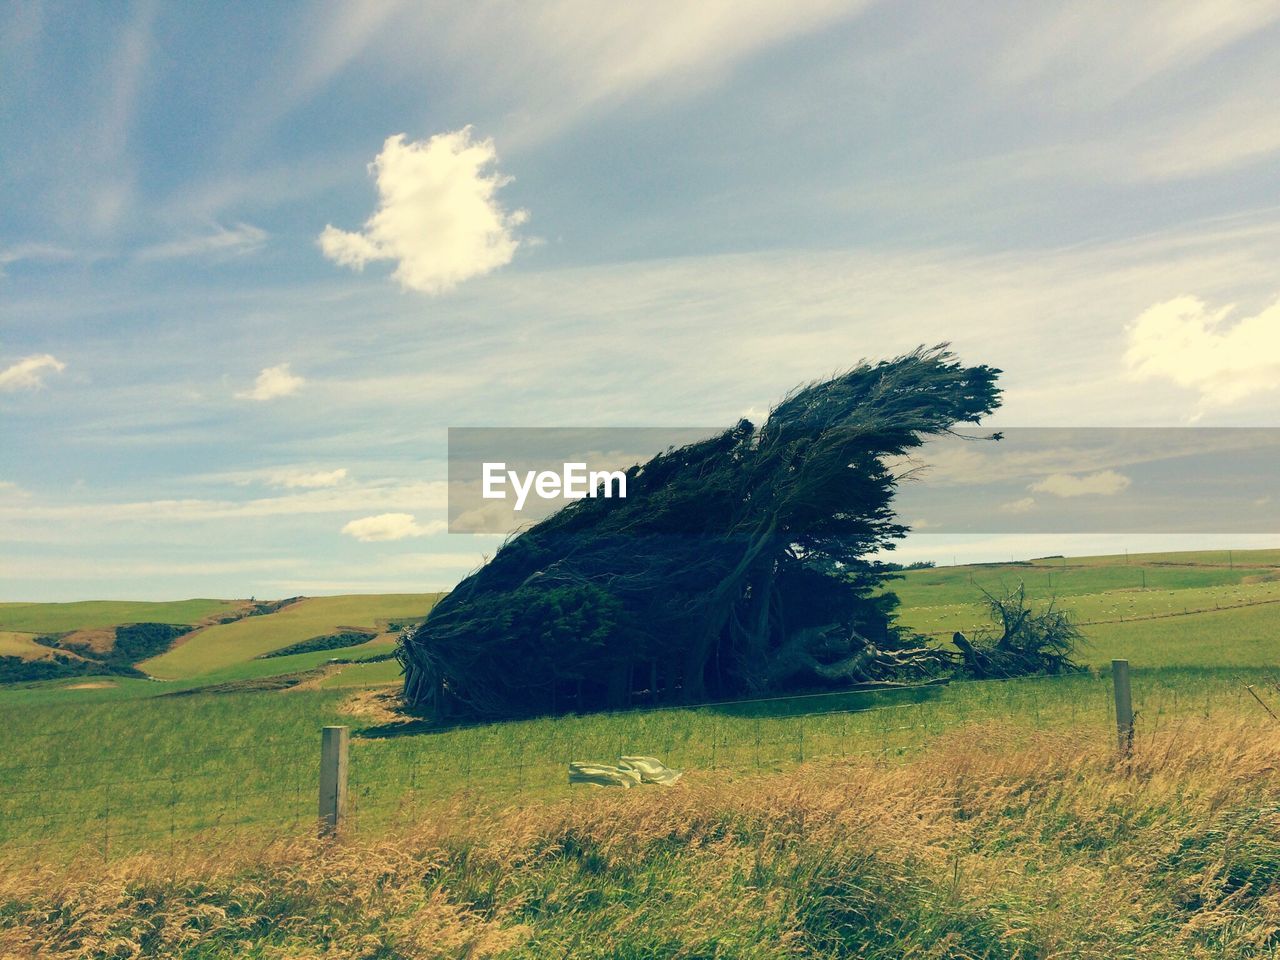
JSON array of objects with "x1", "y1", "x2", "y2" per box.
[{"x1": 0, "y1": 552, "x2": 1280, "y2": 957}]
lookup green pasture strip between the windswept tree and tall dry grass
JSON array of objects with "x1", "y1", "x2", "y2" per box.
[{"x1": 0, "y1": 664, "x2": 1277, "y2": 859}]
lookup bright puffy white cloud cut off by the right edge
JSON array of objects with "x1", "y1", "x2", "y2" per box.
[{"x1": 1125, "y1": 297, "x2": 1280, "y2": 407}]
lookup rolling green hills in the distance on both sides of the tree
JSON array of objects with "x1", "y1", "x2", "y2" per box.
[{"x1": 0, "y1": 550, "x2": 1280, "y2": 703}]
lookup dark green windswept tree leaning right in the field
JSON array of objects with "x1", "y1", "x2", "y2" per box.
[{"x1": 399, "y1": 348, "x2": 998, "y2": 717}]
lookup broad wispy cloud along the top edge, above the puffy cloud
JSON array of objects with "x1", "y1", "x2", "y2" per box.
[{"x1": 262, "y1": 0, "x2": 873, "y2": 148}]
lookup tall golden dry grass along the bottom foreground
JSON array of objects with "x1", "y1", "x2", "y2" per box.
[{"x1": 0, "y1": 717, "x2": 1280, "y2": 959}]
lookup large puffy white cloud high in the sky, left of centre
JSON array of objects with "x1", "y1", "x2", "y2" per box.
[{"x1": 320, "y1": 127, "x2": 527, "y2": 294}]
